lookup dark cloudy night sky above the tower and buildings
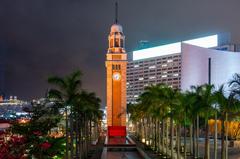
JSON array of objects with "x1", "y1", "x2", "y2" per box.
[{"x1": 0, "y1": 0, "x2": 240, "y2": 104}]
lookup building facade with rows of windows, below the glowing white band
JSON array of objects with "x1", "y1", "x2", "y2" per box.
[{"x1": 127, "y1": 53, "x2": 181, "y2": 103}]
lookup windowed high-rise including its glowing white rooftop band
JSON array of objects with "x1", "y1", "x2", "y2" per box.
[{"x1": 127, "y1": 35, "x2": 239, "y2": 103}]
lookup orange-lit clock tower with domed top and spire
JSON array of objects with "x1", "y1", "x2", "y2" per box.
[{"x1": 105, "y1": 4, "x2": 127, "y2": 134}]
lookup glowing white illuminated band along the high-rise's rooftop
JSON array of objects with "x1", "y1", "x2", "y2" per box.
[{"x1": 133, "y1": 35, "x2": 218, "y2": 60}]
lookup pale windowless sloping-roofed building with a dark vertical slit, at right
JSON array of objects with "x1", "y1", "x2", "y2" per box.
[{"x1": 181, "y1": 43, "x2": 240, "y2": 90}]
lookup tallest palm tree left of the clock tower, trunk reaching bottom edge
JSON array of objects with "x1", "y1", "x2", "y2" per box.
[{"x1": 48, "y1": 71, "x2": 81, "y2": 159}]
